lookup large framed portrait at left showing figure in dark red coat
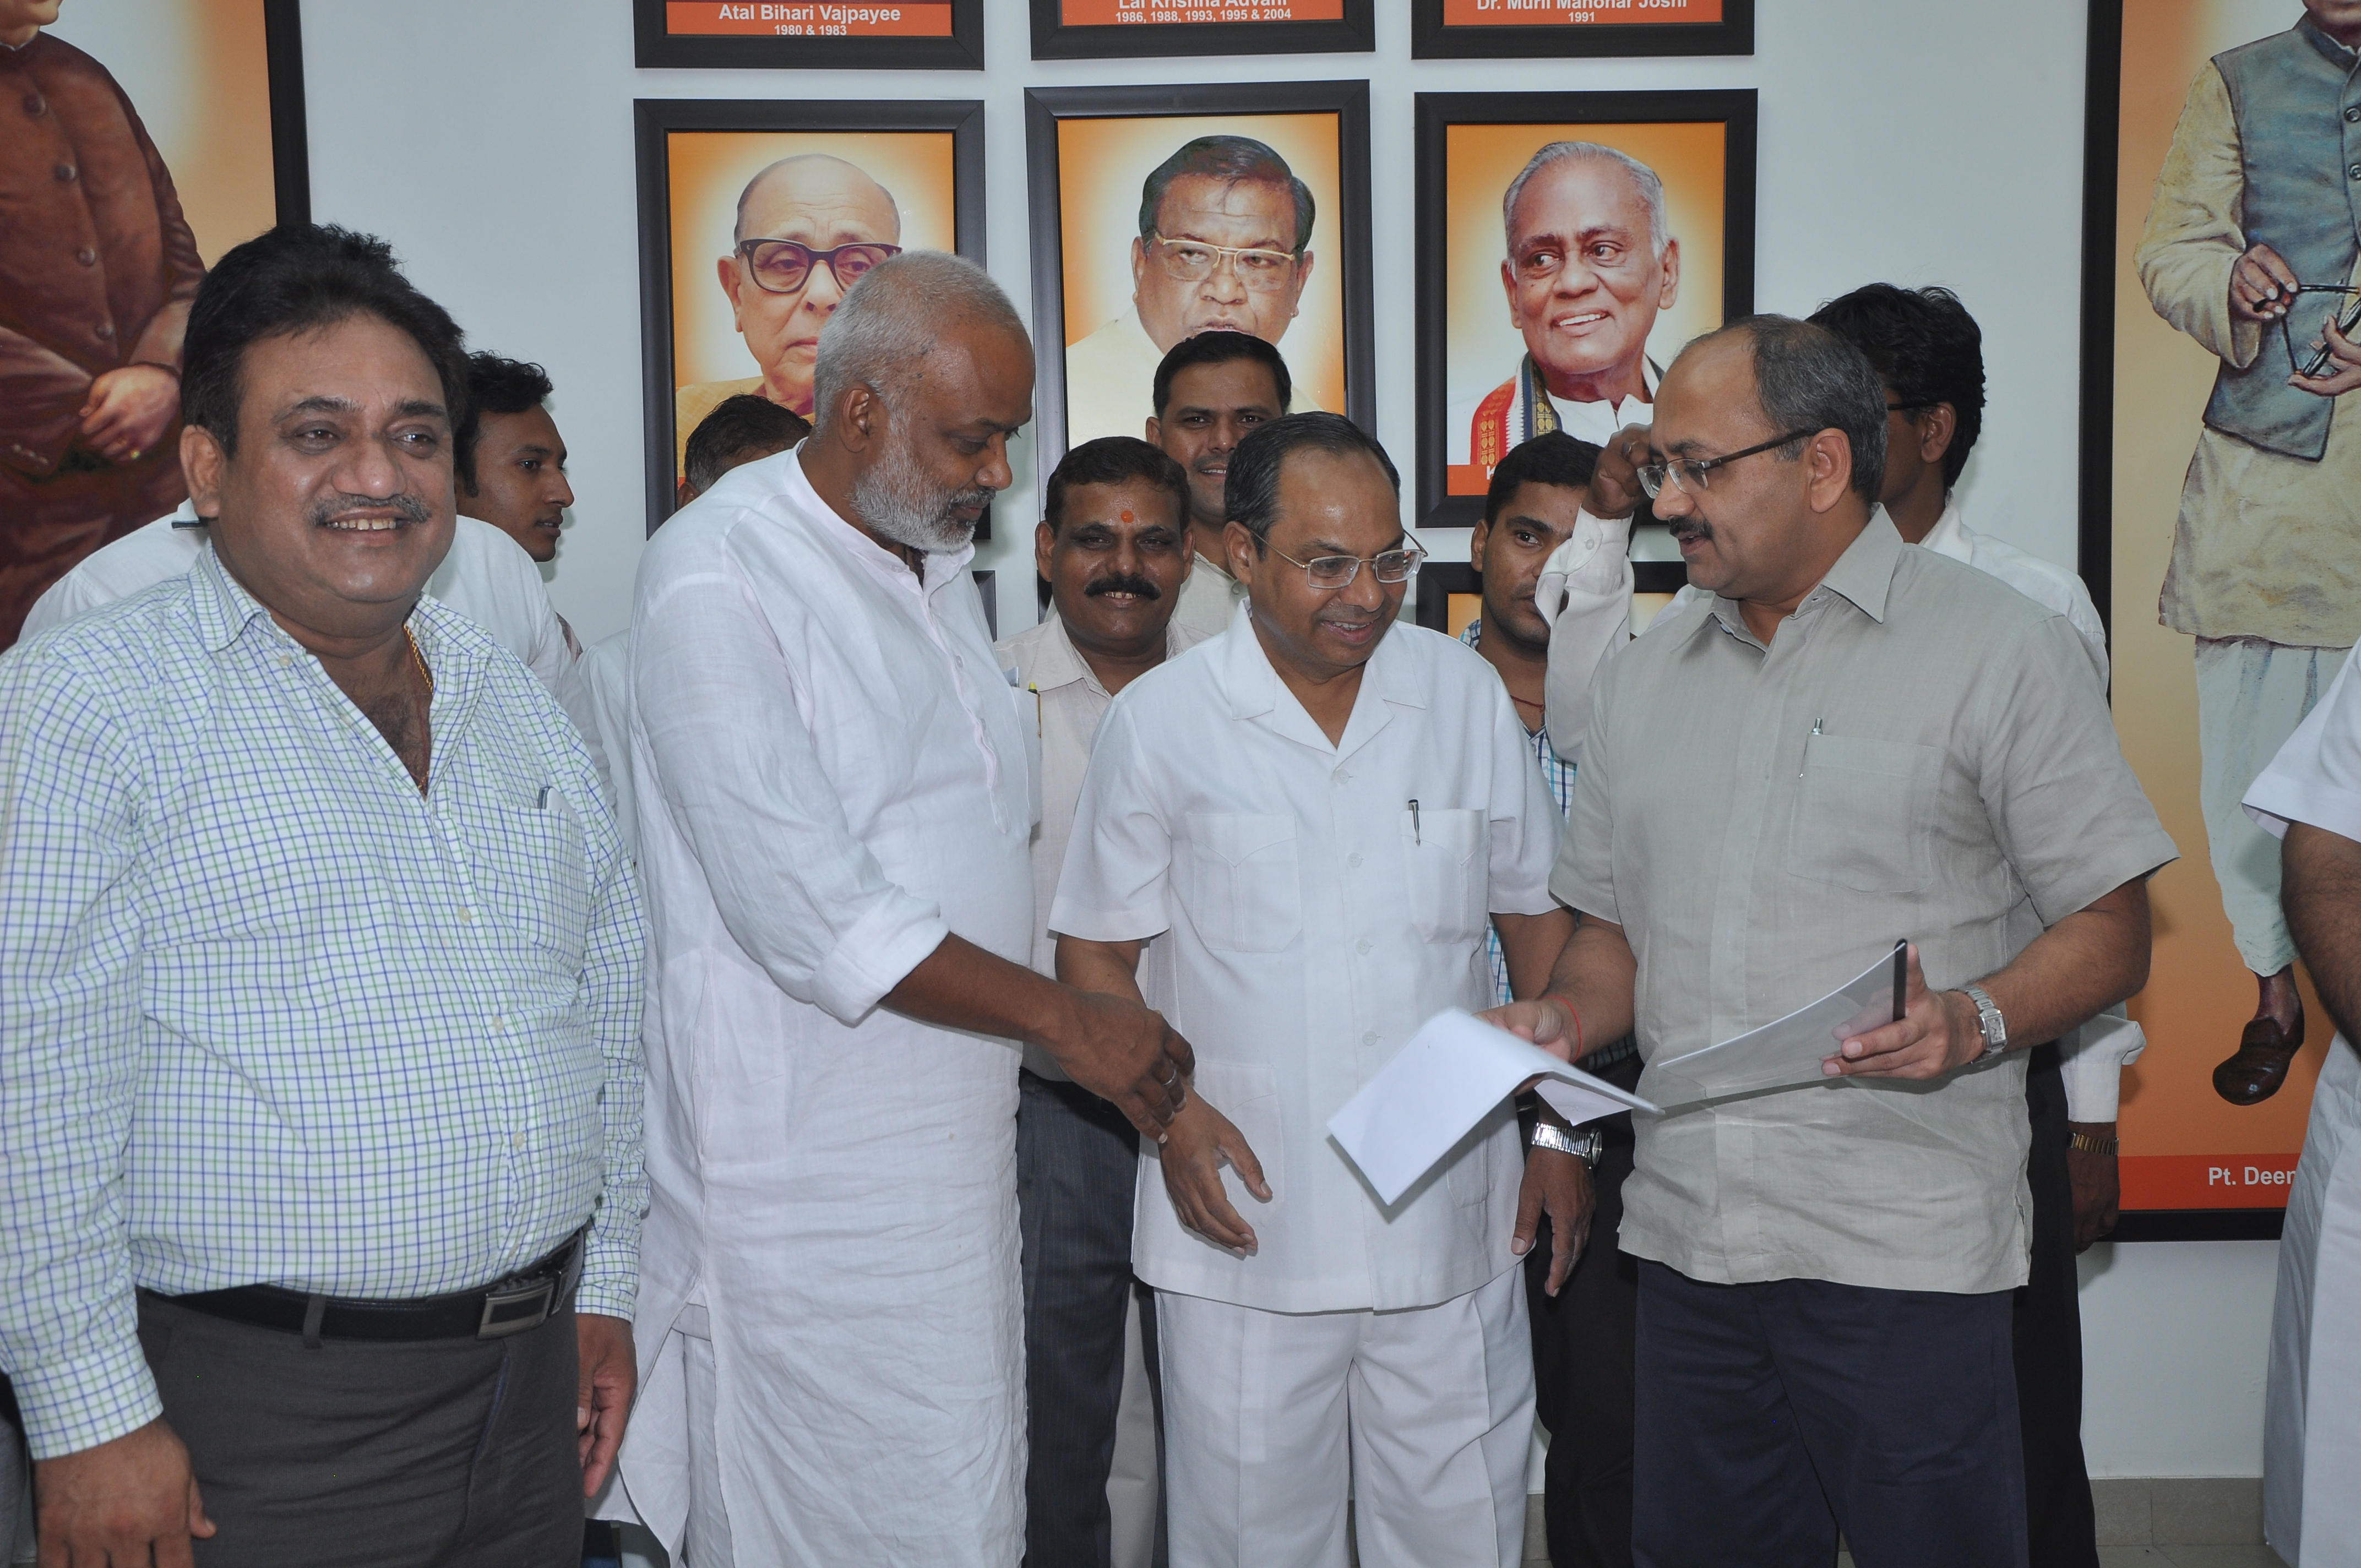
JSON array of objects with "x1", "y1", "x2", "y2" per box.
[{"x1": 0, "y1": 0, "x2": 312, "y2": 650}]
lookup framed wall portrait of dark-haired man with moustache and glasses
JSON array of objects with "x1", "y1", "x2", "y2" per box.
[{"x1": 1025, "y1": 83, "x2": 1377, "y2": 508}]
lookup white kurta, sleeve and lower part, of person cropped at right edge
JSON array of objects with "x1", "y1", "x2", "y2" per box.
[{"x1": 2245, "y1": 659, "x2": 2361, "y2": 1568}]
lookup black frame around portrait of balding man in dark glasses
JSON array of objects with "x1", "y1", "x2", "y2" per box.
[{"x1": 630, "y1": 99, "x2": 992, "y2": 538}]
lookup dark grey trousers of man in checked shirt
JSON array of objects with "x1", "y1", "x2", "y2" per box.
[{"x1": 139, "y1": 1292, "x2": 583, "y2": 1568}]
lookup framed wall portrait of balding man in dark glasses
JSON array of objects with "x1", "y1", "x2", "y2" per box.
[{"x1": 633, "y1": 99, "x2": 984, "y2": 529}]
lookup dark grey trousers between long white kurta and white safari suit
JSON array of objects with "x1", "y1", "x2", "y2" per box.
[{"x1": 1018, "y1": 1072, "x2": 1164, "y2": 1568}]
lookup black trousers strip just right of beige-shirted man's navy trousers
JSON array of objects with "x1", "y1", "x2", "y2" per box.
[{"x1": 2014, "y1": 1046, "x2": 2099, "y2": 1568}]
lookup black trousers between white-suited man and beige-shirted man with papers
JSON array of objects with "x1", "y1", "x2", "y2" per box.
[{"x1": 1525, "y1": 1055, "x2": 1641, "y2": 1568}]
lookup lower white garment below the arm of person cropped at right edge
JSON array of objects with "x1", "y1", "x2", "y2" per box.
[{"x1": 2262, "y1": 1035, "x2": 2361, "y2": 1568}]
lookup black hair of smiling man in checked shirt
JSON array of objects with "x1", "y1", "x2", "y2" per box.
[{"x1": 179, "y1": 224, "x2": 475, "y2": 472}]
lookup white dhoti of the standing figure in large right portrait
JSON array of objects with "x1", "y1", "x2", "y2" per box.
[{"x1": 2196, "y1": 638, "x2": 2352, "y2": 975}]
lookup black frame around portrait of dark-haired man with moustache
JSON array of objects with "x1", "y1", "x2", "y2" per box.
[{"x1": 1025, "y1": 80, "x2": 1377, "y2": 508}]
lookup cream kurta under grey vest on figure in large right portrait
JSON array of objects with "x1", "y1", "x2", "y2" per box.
[{"x1": 2132, "y1": 64, "x2": 2361, "y2": 647}]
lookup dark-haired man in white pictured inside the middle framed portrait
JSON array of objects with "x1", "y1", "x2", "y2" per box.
[{"x1": 1065, "y1": 137, "x2": 1318, "y2": 447}]
